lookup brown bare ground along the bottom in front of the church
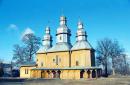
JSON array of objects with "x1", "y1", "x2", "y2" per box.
[{"x1": 0, "y1": 77, "x2": 130, "y2": 85}]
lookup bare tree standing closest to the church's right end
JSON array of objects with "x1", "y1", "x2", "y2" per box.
[{"x1": 96, "y1": 38, "x2": 112, "y2": 77}]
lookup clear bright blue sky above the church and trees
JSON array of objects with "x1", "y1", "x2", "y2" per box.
[{"x1": 0, "y1": 0, "x2": 130, "y2": 61}]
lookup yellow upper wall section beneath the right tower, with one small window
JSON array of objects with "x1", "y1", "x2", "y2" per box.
[{"x1": 71, "y1": 50, "x2": 91, "y2": 67}]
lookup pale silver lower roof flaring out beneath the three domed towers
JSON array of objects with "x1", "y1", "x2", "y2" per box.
[{"x1": 37, "y1": 40, "x2": 93, "y2": 53}]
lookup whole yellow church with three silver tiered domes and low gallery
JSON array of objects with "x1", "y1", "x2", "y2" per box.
[{"x1": 20, "y1": 16, "x2": 101, "y2": 79}]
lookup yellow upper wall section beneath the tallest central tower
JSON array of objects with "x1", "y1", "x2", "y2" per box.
[{"x1": 46, "y1": 52, "x2": 70, "y2": 68}]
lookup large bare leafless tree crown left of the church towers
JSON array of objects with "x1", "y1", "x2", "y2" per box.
[{"x1": 13, "y1": 33, "x2": 41, "y2": 67}]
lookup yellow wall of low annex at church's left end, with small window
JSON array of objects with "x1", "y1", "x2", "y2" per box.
[{"x1": 20, "y1": 66, "x2": 35, "y2": 78}]
